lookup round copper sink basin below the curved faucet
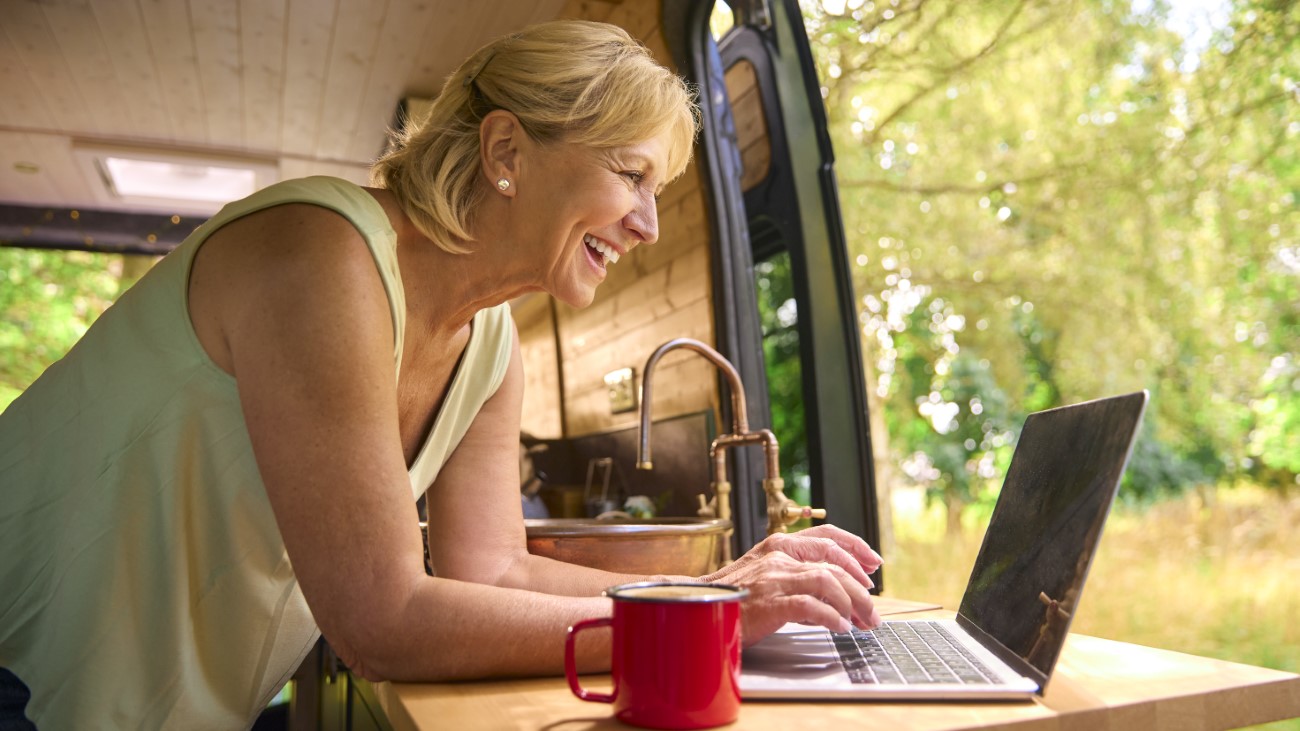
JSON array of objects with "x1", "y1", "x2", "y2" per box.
[{"x1": 524, "y1": 518, "x2": 732, "y2": 576}]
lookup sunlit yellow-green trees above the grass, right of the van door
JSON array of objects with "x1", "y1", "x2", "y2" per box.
[{"x1": 805, "y1": 0, "x2": 1300, "y2": 515}]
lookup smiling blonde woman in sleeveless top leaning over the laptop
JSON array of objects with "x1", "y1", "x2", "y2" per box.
[{"x1": 0, "y1": 22, "x2": 880, "y2": 728}]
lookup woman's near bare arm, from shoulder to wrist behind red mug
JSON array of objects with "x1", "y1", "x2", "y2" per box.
[{"x1": 191, "y1": 206, "x2": 624, "y2": 680}]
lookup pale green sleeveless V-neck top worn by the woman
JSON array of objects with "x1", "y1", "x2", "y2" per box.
[{"x1": 0, "y1": 177, "x2": 511, "y2": 730}]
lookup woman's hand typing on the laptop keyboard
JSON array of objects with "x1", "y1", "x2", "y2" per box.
[{"x1": 701, "y1": 525, "x2": 881, "y2": 646}]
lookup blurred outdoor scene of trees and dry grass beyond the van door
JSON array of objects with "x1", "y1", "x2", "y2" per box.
[{"x1": 759, "y1": 0, "x2": 1300, "y2": 728}]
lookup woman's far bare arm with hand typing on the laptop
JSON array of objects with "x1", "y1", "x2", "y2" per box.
[{"x1": 428, "y1": 318, "x2": 880, "y2": 642}]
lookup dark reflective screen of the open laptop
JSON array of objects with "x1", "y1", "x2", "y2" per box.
[{"x1": 958, "y1": 392, "x2": 1147, "y2": 685}]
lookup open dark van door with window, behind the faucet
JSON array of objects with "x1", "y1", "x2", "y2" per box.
[{"x1": 663, "y1": 0, "x2": 880, "y2": 572}]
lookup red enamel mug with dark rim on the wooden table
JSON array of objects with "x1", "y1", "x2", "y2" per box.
[{"x1": 564, "y1": 583, "x2": 749, "y2": 728}]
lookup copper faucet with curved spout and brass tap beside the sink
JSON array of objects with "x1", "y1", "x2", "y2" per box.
[{"x1": 637, "y1": 338, "x2": 826, "y2": 562}]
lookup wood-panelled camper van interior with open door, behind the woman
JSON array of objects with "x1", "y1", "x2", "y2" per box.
[{"x1": 0, "y1": 0, "x2": 883, "y2": 728}]
